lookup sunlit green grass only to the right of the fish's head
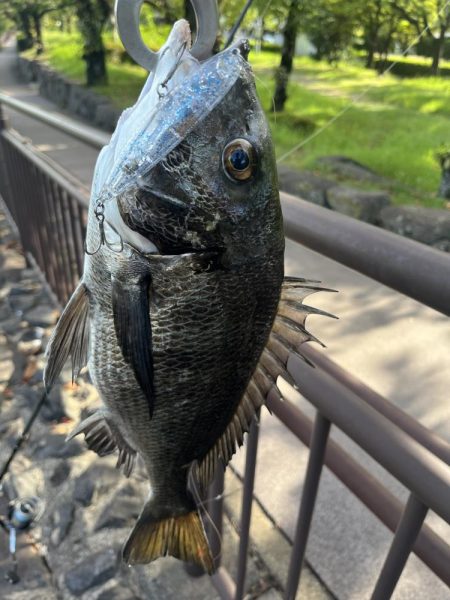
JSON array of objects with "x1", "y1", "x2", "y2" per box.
[{"x1": 251, "y1": 59, "x2": 450, "y2": 207}]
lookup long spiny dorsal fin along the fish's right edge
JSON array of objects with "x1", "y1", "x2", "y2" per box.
[{"x1": 195, "y1": 277, "x2": 336, "y2": 489}]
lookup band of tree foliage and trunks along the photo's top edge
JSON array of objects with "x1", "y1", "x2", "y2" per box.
[{"x1": 4, "y1": 0, "x2": 450, "y2": 88}]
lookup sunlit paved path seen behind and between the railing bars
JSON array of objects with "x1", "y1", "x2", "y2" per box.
[{"x1": 0, "y1": 39, "x2": 450, "y2": 600}]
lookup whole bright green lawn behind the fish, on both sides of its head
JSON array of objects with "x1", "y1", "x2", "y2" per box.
[{"x1": 24, "y1": 29, "x2": 450, "y2": 207}]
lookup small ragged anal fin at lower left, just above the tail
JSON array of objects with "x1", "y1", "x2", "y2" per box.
[{"x1": 66, "y1": 410, "x2": 136, "y2": 477}]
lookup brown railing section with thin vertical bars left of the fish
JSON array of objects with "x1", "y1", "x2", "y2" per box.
[{"x1": 0, "y1": 95, "x2": 90, "y2": 305}]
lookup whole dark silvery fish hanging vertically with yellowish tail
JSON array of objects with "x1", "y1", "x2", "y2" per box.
[{"x1": 44, "y1": 20, "x2": 334, "y2": 574}]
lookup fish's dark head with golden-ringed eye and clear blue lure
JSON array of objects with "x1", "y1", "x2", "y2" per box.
[{"x1": 96, "y1": 21, "x2": 284, "y2": 265}]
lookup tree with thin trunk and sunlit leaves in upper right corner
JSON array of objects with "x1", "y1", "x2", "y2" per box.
[{"x1": 391, "y1": 0, "x2": 450, "y2": 75}]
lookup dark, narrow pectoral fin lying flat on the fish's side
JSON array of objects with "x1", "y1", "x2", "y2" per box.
[{"x1": 112, "y1": 274, "x2": 154, "y2": 417}]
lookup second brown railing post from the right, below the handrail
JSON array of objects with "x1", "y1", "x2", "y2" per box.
[{"x1": 284, "y1": 412, "x2": 331, "y2": 600}]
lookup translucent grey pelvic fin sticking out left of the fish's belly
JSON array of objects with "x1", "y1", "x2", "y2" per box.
[{"x1": 44, "y1": 281, "x2": 89, "y2": 391}]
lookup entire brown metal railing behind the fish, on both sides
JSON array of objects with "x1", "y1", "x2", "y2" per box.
[{"x1": 0, "y1": 95, "x2": 450, "y2": 600}]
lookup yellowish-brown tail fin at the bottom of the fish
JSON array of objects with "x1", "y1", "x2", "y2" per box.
[{"x1": 122, "y1": 504, "x2": 214, "y2": 575}]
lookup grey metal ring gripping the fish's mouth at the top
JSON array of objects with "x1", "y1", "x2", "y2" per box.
[{"x1": 115, "y1": 0, "x2": 219, "y2": 72}]
